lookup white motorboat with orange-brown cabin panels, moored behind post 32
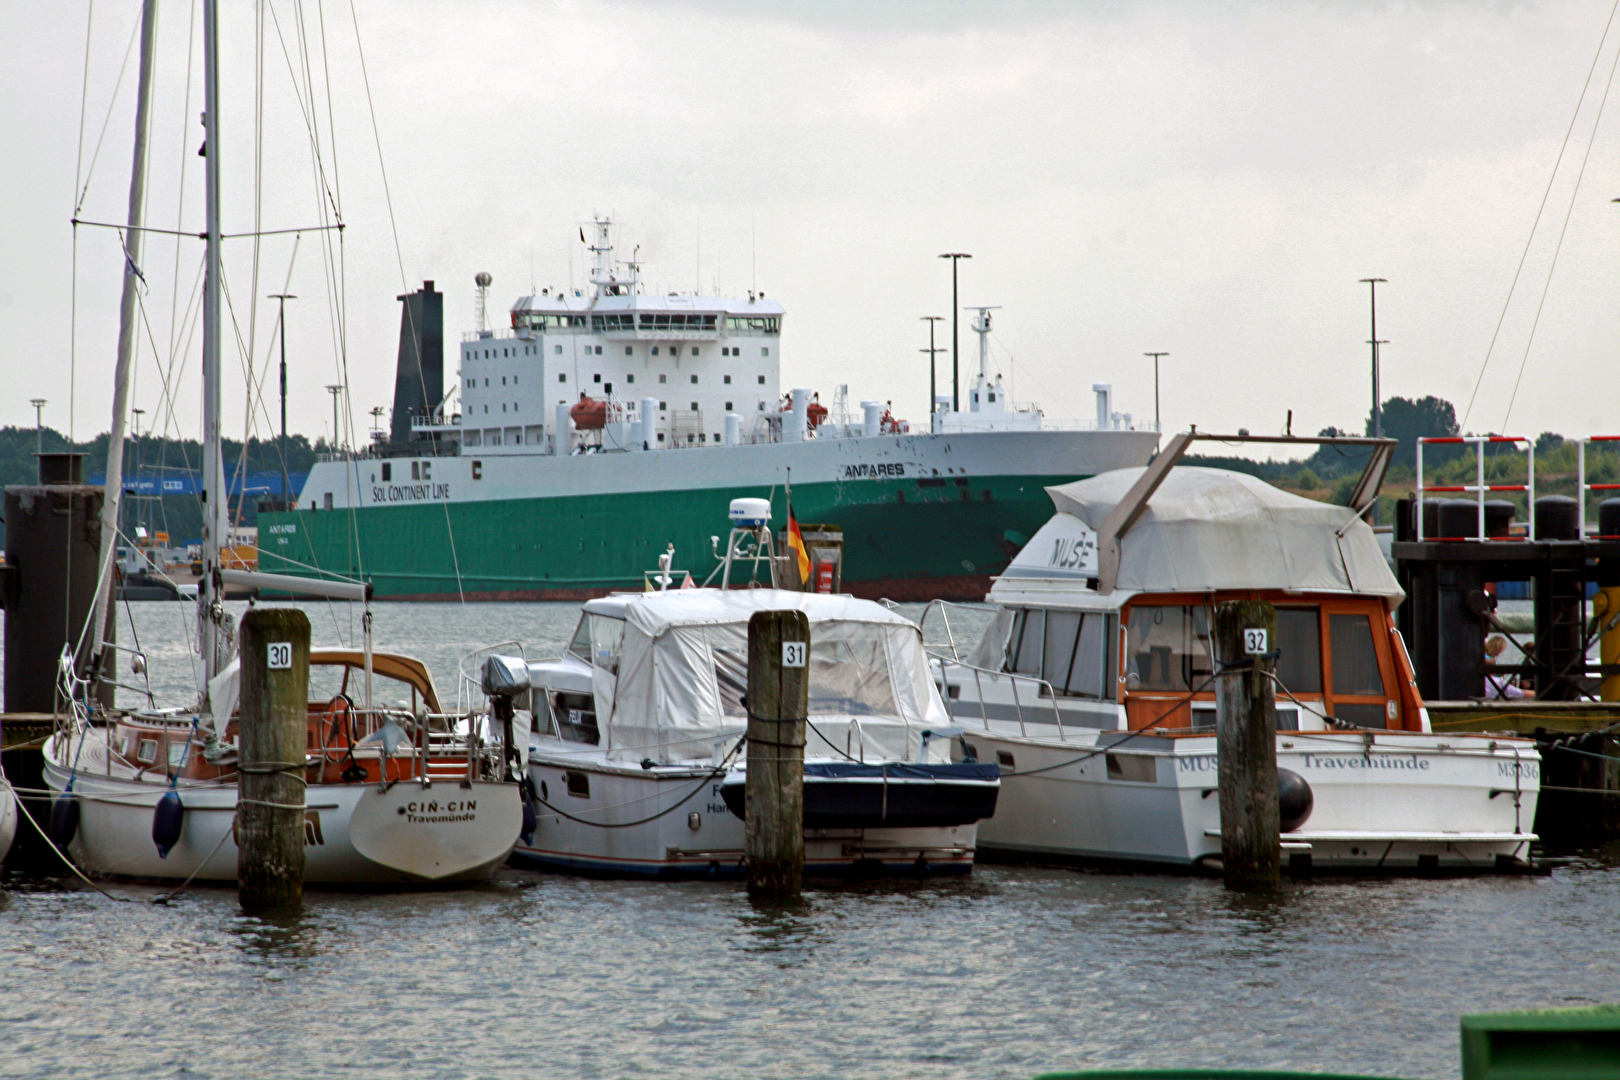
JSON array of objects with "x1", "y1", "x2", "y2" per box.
[{"x1": 923, "y1": 436, "x2": 1541, "y2": 873}]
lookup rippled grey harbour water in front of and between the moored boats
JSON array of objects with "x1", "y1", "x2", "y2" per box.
[{"x1": 0, "y1": 604, "x2": 1620, "y2": 1078}]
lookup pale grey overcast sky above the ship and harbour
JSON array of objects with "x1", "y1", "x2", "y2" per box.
[{"x1": 0, "y1": 0, "x2": 1620, "y2": 456}]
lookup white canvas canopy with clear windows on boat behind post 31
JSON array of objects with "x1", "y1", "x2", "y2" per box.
[{"x1": 585, "y1": 589, "x2": 949, "y2": 761}]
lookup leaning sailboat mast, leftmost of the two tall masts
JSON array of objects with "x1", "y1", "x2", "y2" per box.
[{"x1": 91, "y1": 0, "x2": 157, "y2": 680}]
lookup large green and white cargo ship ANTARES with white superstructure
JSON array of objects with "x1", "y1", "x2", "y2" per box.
[{"x1": 259, "y1": 219, "x2": 1158, "y2": 601}]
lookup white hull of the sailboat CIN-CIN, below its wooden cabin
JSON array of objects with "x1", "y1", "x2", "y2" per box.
[{"x1": 45, "y1": 732, "x2": 523, "y2": 887}]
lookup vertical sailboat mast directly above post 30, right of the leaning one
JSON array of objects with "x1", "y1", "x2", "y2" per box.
[{"x1": 198, "y1": 0, "x2": 227, "y2": 689}]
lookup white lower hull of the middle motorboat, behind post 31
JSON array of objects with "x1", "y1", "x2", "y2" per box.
[{"x1": 512, "y1": 745, "x2": 975, "y2": 878}]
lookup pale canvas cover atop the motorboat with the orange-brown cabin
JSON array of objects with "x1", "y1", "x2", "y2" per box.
[{"x1": 1004, "y1": 465, "x2": 1406, "y2": 604}]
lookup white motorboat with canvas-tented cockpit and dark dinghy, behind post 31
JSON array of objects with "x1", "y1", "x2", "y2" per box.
[{"x1": 484, "y1": 588, "x2": 1000, "y2": 878}]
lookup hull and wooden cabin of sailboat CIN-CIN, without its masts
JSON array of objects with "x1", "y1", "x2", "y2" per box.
[{"x1": 44, "y1": 649, "x2": 523, "y2": 887}]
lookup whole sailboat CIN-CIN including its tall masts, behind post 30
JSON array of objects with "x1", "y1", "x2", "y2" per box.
[{"x1": 39, "y1": 0, "x2": 528, "y2": 886}]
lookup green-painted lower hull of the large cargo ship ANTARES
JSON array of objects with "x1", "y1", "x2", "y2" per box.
[{"x1": 259, "y1": 474, "x2": 1082, "y2": 601}]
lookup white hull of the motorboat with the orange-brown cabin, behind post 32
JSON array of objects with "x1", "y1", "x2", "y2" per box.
[{"x1": 966, "y1": 721, "x2": 1541, "y2": 873}]
